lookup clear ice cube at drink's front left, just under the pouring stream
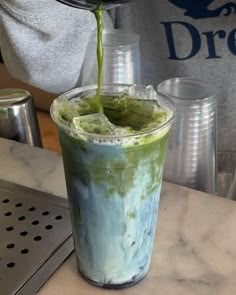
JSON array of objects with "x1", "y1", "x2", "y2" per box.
[{"x1": 73, "y1": 113, "x2": 115, "y2": 135}]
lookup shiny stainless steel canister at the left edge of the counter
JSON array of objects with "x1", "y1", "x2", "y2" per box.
[{"x1": 0, "y1": 88, "x2": 42, "y2": 147}]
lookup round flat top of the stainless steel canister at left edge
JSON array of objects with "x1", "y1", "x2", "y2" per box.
[{"x1": 0, "y1": 88, "x2": 31, "y2": 107}]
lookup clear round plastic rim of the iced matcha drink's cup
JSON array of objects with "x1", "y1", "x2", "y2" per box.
[{"x1": 50, "y1": 84, "x2": 177, "y2": 140}]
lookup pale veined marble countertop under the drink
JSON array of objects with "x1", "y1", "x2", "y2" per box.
[{"x1": 0, "y1": 139, "x2": 236, "y2": 295}]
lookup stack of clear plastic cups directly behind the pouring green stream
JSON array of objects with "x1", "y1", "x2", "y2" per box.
[{"x1": 79, "y1": 29, "x2": 141, "y2": 86}]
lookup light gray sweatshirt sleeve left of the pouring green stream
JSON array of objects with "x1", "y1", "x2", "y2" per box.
[{"x1": 0, "y1": 0, "x2": 96, "y2": 93}]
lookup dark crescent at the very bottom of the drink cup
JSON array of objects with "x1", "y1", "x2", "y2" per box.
[{"x1": 78, "y1": 268, "x2": 147, "y2": 290}]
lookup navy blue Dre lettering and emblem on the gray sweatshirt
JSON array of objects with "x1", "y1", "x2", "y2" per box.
[{"x1": 161, "y1": 0, "x2": 236, "y2": 60}]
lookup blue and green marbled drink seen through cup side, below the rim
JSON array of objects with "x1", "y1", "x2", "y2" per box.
[{"x1": 59, "y1": 127, "x2": 169, "y2": 286}]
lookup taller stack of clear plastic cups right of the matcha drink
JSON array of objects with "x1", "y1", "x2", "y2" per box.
[{"x1": 158, "y1": 78, "x2": 217, "y2": 193}]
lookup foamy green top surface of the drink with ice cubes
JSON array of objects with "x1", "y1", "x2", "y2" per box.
[{"x1": 54, "y1": 86, "x2": 173, "y2": 145}]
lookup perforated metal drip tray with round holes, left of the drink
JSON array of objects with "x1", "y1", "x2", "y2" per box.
[{"x1": 0, "y1": 180, "x2": 73, "y2": 295}]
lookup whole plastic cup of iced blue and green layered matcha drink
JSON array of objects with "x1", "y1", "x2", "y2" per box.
[{"x1": 51, "y1": 85, "x2": 174, "y2": 288}]
